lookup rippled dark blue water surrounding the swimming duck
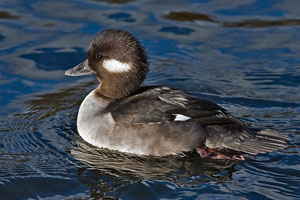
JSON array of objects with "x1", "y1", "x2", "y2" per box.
[{"x1": 0, "y1": 0, "x2": 300, "y2": 199}]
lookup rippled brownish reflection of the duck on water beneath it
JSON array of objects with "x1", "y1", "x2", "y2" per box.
[{"x1": 71, "y1": 135, "x2": 235, "y2": 185}]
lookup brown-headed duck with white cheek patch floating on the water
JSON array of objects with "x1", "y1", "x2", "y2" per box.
[{"x1": 65, "y1": 29, "x2": 288, "y2": 160}]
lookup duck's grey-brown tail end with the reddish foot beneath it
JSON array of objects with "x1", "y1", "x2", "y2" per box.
[{"x1": 196, "y1": 126, "x2": 290, "y2": 160}]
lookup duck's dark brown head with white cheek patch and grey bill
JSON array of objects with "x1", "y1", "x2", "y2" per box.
[{"x1": 65, "y1": 29, "x2": 148, "y2": 99}]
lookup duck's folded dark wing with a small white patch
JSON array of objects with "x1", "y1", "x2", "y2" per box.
[{"x1": 107, "y1": 87, "x2": 243, "y2": 126}]
